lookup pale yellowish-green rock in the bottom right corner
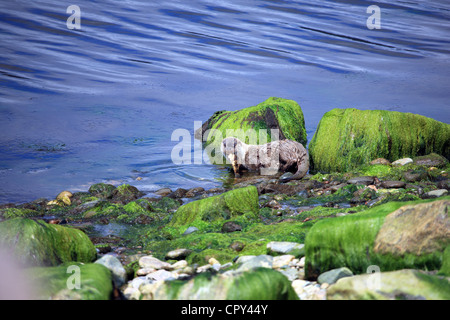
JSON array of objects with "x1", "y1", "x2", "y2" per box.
[{"x1": 327, "y1": 270, "x2": 450, "y2": 300}]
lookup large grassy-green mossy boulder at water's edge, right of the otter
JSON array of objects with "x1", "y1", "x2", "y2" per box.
[{"x1": 309, "y1": 108, "x2": 450, "y2": 172}]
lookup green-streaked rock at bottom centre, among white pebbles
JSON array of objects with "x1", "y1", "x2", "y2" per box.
[{"x1": 153, "y1": 268, "x2": 298, "y2": 300}]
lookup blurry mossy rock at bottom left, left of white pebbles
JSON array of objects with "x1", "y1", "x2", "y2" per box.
[{"x1": 28, "y1": 263, "x2": 113, "y2": 300}]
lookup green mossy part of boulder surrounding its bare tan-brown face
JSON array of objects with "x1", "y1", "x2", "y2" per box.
[{"x1": 305, "y1": 197, "x2": 450, "y2": 279}]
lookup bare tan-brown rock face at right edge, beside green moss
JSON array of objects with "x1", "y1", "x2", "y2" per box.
[{"x1": 374, "y1": 200, "x2": 450, "y2": 257}]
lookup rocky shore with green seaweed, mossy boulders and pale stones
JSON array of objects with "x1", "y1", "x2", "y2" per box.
[{"x1": 0, "y1": 100, "x2": 450, "y2": 300}]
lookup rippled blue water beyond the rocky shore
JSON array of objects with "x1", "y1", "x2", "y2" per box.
[{"x1": 0, "y1": 0, "x2": 450, "y2": 203}]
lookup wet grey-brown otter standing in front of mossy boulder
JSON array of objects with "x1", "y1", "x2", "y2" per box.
[{"x1": 220, "y1": 137, "x2": 309, "y2": 182}]
